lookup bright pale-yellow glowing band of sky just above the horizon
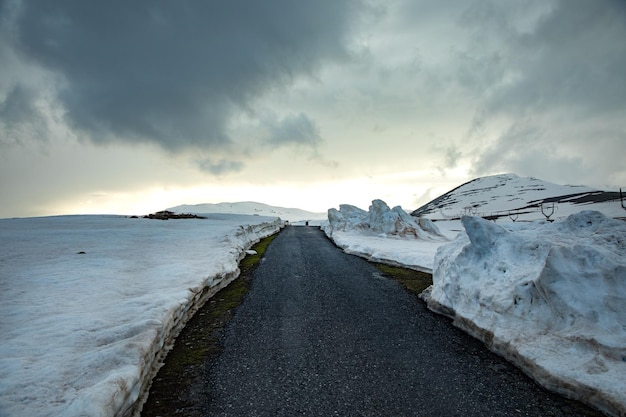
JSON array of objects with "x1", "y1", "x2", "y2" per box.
[{"x1": 51, "y1": 172, "x2": 460, "y2": 215}]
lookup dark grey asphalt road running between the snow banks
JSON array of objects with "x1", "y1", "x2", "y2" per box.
[{"x1": 202, "y1": 226, "x2": 595, "y2": 417}]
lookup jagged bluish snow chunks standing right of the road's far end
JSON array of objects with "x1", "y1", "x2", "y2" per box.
[{"x1": 322, "y1": 200, "x2": 446, "y2": 241}]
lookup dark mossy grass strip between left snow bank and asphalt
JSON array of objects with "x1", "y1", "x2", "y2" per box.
[{"x1": 141, "y1": 234, "x2": 277, "y2": 417}]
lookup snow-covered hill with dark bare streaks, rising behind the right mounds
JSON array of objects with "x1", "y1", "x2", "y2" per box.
[{"x1": 411, "y1": 174, "x2": 626, "y2": 220}]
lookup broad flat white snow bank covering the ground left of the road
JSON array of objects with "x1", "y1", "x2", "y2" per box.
[{"x1": 0, "y1": 215, "x2": 282, "y2": 417}]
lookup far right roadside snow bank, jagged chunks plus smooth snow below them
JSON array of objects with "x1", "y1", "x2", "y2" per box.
[{"x1": 321, "y1": 200, "x2": 448, "y2": 273}]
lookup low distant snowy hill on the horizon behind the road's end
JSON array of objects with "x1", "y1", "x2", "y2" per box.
[{"x1": 168, "y1": 201, "x2": 326, "y2": 223}]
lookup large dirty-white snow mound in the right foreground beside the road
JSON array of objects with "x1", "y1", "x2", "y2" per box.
[{"x1": 422, "y1": 211, "x2": 626, "y2": 416}]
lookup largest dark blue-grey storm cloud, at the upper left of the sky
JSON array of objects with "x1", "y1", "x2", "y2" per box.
[{"x1": 0, "y1": 0, "x2": 354, "y2": 149}]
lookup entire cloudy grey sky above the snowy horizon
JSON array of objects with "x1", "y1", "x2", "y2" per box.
[{"x1": 0, "y1": 0, "x2": 626, "y2": 217}]
